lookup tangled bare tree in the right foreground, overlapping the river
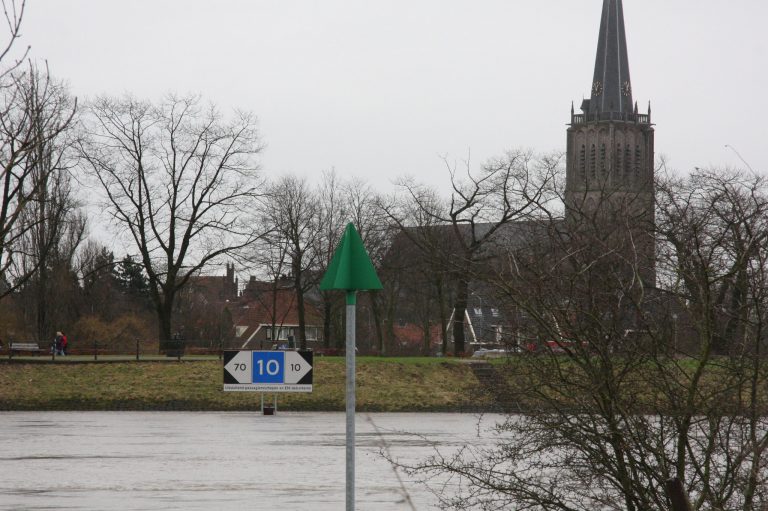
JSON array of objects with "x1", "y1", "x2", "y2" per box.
[{"x1": 396, "y1": 172, "x2": 768, "y2": 511}]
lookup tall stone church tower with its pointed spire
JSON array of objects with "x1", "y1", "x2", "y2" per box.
[{"x1": 565, "y1": 0, "x2": 655, "y2": 281}]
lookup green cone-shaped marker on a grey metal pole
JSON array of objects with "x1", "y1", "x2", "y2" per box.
[{"x1": 320, "y1": 223, "x2": 383, "y2": 511}]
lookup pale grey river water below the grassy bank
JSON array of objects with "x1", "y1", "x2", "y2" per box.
[{"x1": 0, "y1": 411, "x2": 500, "y2": 511}]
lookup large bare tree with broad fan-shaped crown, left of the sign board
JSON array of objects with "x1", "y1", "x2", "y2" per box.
[{"x1": 81, "y1": 95, "x2": 261, "y2": 340}]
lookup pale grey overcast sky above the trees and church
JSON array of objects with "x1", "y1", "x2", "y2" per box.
[{"x1": 15, "y1": 0, "x2": 768, "y2": 189}]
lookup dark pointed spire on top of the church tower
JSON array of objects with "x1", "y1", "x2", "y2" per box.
[{"x1": 589, "y1": 0, "x2": 633, "y2": 114}]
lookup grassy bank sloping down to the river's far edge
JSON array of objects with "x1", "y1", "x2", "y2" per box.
[{"x1": 0, "y1": 357, "x2": 492, "y2": 412}]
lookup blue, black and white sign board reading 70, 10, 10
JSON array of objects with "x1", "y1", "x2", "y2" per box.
[{"x1": 224, "y1": 351, "x2": 313, "y2": 392}]
